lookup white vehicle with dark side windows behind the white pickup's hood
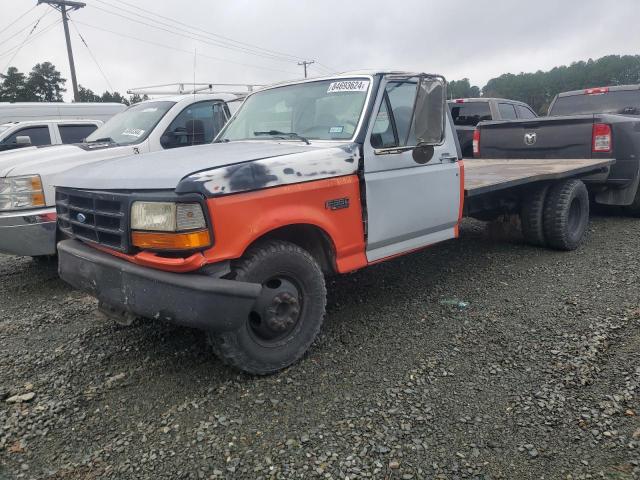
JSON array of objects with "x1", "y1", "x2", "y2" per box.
[{"x1": 0, "y1": 120, "x2": 103, "y2": 153}]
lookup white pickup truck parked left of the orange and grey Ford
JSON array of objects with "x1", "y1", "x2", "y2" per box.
[{"x1": 0, "y1": 93, "x2": 243, "y2": 257}]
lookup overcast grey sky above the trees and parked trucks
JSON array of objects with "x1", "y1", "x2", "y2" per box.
[{"x1": 0, "y1": 0, "x2": 640, "y2": 99}]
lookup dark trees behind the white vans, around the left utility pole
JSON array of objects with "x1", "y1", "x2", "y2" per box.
[{"x1": 0, "y1": 62, "x2": 149, "y2": 105}]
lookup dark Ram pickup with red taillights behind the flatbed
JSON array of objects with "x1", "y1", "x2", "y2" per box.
[{"x1": 473, "y1": 85, "x2": 640, "y2": 215}]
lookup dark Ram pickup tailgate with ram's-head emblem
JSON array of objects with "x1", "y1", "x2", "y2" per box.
[{"x1": 479, "y1": 115, "x2": 593, "y2": 158}]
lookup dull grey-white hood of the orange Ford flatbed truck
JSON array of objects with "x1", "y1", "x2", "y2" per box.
[{"x1": 53, "y1": 140, "x2": 353, "y2": 190}]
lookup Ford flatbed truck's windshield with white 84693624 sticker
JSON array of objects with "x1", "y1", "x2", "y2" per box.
[{"x1": 217, "y1": 78, "x2": 370, "y2": 141}]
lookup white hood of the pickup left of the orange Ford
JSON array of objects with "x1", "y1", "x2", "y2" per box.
[{"x1": 0, "y1": 144, "x2": 138, "y2": 206}]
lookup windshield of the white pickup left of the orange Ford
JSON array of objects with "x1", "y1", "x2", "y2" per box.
[{"x1": 86, "y1": 101, "x2": 175, "y2": 145}]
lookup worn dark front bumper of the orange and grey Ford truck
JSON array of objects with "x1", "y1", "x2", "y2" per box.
[{"x1": 58, "y1": 240, "x2": 262, "y2": 332}]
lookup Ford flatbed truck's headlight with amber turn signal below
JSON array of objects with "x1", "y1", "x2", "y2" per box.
[{"x1": 131, "y1": 202, "x2": 211, "y2": 250}]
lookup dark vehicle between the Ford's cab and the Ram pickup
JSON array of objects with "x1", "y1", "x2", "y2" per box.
[{"x1": 448, "y1": 98, "x2": 537, "y2": 158}]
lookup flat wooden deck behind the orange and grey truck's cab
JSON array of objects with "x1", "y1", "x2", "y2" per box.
[{"x1": 464, "y1": 158, "x2": 615, "y2": 197}]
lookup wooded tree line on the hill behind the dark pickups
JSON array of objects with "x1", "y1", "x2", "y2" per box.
[{"x1": 449, "y1": 55, "x2": 640, "y2": 115}]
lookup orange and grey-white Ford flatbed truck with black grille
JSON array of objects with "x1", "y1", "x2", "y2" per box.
[{"x1": 56, "y1": 71, "x2": 614, "y2": 374}]
